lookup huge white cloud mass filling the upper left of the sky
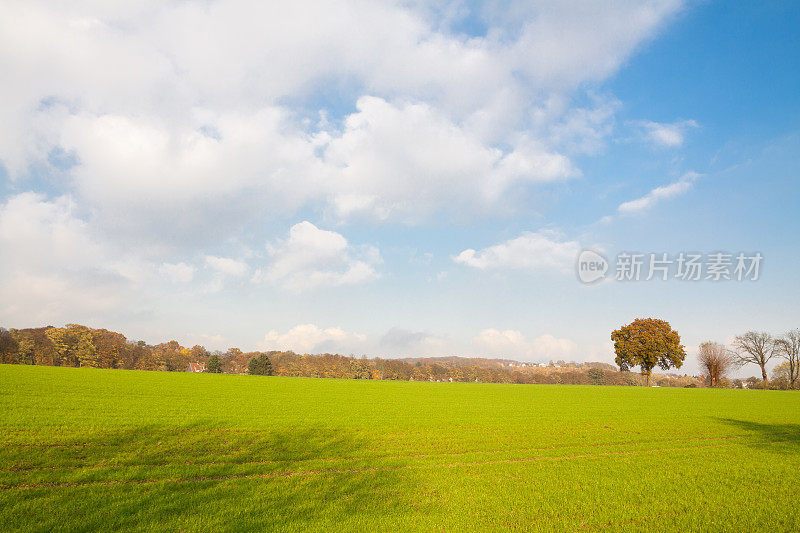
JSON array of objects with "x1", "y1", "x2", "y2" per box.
[{"x1": 0, "y1": 0, "x2": 680, "y2": 236}]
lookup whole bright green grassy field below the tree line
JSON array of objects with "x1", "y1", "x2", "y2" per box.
[{"x1": 0, "y1": 365, "x2": 800, "y2": 531}]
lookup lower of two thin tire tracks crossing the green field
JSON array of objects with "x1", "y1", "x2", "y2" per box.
[{"x1": 0, "y1": 439, "x2": 791, "y2": 490}]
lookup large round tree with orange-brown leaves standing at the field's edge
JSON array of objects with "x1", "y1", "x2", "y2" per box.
[{"x1": 611, "y1": 318, "x2": 686, "y2": 387}]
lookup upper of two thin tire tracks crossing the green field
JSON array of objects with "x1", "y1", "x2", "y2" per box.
[{"x1": 0, "y1": 435, "x2": 753, "y2": 472}]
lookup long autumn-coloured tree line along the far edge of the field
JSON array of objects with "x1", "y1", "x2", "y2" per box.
[{"x1": 0, "y1": 324, "x2": 699, "y2": 387}]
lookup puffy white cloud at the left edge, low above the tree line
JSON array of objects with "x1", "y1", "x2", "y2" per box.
[{"x1": 0, "y1": 193, "x2": 148, "y2": 325}]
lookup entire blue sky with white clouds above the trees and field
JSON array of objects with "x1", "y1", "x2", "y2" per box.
[{"x1": 0, "y1": 0, "x2": 800, "y2": 375}]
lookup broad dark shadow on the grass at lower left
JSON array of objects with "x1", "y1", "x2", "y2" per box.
[{"x1": 0, "y1": 424, "x2": 424, "y2": 531}]
